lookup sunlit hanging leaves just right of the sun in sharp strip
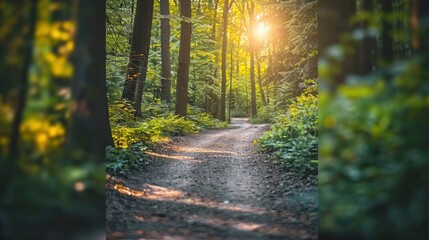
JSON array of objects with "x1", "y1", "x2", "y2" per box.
[{"x1": 265, "y1": 0, "x2": 318, "y2": 108}]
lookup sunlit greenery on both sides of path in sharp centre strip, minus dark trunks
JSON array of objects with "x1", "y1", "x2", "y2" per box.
[{"x1": 106, "y1": 0, "x2": 318, "y2": 177}]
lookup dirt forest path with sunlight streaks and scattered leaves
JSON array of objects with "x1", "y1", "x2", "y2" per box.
[{"x1": 106, "y1": 119, "x2": 318, "y2": 240}]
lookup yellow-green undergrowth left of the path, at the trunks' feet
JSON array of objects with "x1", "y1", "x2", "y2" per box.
[{"x1": 106, "y1": 101, "x2": 228, "y2": 173}]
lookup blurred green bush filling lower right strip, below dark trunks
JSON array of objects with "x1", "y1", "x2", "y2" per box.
[{"x1": 319, "y1": 57, "x2": 429, "y2": 239}]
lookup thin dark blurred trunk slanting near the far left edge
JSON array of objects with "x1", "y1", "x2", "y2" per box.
[{"x1": 8, "y1": 0, "x2": 37, "y2": 159}]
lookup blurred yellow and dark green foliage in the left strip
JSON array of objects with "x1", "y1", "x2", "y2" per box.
[{"x1": 0, "y1": 0, "x2": 105, "y2": 239}]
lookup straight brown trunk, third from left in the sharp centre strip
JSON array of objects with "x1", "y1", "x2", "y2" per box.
[{"x1": 176, "y1": 0, "x2": 192, "y2": 116}]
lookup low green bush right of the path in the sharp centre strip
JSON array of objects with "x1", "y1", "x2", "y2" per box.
[{"x1": 259, "y1": 81, "x2": 318, "y2": 175}]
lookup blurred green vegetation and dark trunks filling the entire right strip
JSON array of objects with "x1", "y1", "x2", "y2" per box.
[{"x1": 319, "y1": 0, "x2": 429, "y2": 239}]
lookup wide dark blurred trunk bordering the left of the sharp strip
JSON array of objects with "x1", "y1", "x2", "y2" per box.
[{"x1": 67, "y1": 0, "x2": 113, "y2": 158}]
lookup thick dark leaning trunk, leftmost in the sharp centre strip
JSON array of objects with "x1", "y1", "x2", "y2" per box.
[{"x1": 122, "y1": 0, "x2": 154, "y2": 108}]
